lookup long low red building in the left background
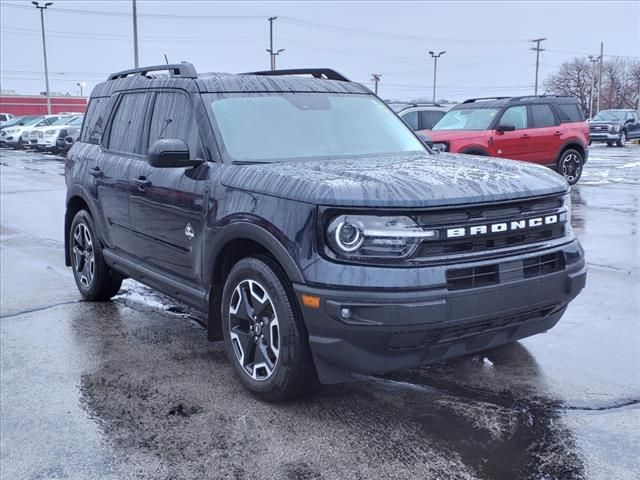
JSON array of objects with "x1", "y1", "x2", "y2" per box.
[{"x1": 0, "y1": 90, "x2": 87, "y2": 115}]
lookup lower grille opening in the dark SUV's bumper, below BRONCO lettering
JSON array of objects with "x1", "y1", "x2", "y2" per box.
[{"x1": 447, "y1": 252, "x2": 565, "y2": 290}]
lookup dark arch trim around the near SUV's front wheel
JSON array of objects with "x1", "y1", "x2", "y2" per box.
[{"x1": 204, "y1": 222, "x2": 304, "y2": 341}]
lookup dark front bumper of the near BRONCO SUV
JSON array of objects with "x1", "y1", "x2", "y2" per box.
[{"x1": 294, "y1": 241, "x2": 586, "y2": 383}]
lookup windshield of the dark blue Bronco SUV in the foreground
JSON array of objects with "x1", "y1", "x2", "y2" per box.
[{"x1": 208, "y1": 93, "x2": 425, "y2": 162}]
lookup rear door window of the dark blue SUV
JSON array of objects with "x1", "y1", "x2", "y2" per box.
[{"x1": 108, "y1": 93, "x2": 149, "y2": 155}]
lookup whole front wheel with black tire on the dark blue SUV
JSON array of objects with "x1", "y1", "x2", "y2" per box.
[{"x1": 221, "y1": 256, "x2": 316, "y2": 402}]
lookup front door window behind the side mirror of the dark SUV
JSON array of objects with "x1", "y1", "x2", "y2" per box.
[{"x1": 149, "y1": 92, "x2": 202, "y2": 160}]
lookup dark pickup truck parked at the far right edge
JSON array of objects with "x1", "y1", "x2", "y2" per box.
[{"x1": 587, "y1": 110, "x2": 640, "y2": 147}]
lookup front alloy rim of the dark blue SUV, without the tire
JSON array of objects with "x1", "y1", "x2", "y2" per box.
[{"x1": 229, "y1": 280, "x2": 280, "y2": 381}]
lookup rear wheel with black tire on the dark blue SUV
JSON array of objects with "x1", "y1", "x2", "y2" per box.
[{"x1": 67, "y1": 210, "x2": 122, "y2": 301}]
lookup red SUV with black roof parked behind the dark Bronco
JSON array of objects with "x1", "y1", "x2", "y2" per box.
[{"x1": 427, "y1": 95, "x2": 589, "y2": 185}]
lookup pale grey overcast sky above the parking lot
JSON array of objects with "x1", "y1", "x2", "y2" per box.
[{"x1": 0, "y1": 0, "x2": 640, "y2": 100}]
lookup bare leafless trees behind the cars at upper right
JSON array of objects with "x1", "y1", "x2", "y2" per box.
[{"x1": 545, "y1": 57, "x2": 640, "y2": 113}]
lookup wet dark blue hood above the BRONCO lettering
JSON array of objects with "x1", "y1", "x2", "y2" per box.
[{"x1": 221, "y1": 153, "x2": 567, "y2": 207}]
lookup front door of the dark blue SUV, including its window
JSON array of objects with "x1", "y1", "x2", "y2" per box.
[{"x1": 129, "y1": 92, "x2": 210, "y2": 284}]
